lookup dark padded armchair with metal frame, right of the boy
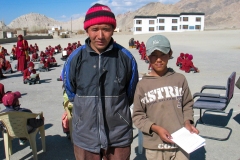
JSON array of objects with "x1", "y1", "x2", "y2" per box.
[{"x1": 193, "y1": 72, "x2": 236, "y2": 141}]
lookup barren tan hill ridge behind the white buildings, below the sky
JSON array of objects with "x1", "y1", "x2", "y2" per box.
[{"x1": 0, "y1": 0, "x2": 240, "y2": 31}]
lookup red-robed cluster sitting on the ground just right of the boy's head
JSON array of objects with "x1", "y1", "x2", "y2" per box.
[{"x1": 176, "y1": 53, "x2": 200, "y2": 73}]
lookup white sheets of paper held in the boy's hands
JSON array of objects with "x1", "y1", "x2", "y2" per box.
[{"x1": 171, "y1": 127, "x2": 206, "y2": 153}]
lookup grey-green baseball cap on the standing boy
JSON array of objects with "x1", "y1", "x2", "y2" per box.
[{"x1": 146, "y1": 35, "x2": 171, "y2": 56}]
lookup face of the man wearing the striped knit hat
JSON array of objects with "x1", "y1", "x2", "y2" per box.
[{"x1": 87, "y1": 24, "x2": 114, "y2": 53}]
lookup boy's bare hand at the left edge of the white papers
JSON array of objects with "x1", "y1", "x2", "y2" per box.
[{"x1": 151, "y1": 124, "x2": 174, "y2": 143}]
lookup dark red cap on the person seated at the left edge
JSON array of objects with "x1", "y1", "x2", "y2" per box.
[{"x1": 2, "y1": 91, "x2": 21, "y2": 106}]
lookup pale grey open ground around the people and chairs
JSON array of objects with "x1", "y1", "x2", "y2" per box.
[{"x1": 0, "y1": 30, "x2": 240, "y2": 160}]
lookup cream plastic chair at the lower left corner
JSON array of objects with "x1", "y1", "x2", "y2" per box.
[{"x1": 0, "y1": 112, "x2": 46, "y2": 160}]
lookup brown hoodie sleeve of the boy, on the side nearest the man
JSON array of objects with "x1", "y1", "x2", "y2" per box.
[{"x1": 132, "y1": 84, "x2": 154, "y2": 135}]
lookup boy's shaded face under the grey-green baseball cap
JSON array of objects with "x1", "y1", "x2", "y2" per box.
[{"x1": 149, "y1": 50, "x2": 172, "y2": 76}]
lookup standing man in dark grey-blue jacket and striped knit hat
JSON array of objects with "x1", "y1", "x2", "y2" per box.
[{"x1": 62, "y1": 4, "x2": 138, "y2": 160}]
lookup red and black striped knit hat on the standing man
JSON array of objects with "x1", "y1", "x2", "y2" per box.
[{"x1": 84, "y1": 3, "x2": 117, "y2": 30}]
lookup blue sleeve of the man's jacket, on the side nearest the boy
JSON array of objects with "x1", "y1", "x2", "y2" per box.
[{"x1": 127, "y1": 57, "x2": 138, "y2": 106}]
